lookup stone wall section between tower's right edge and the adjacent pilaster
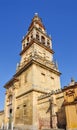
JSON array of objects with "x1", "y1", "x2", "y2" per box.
[{"x1": 38, "y1": 98, "x2": 50, "y2": 129}]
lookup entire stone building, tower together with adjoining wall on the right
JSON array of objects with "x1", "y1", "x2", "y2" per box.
[{"x1": 2, "y1": 13, "x2": 77, "y2": 130}]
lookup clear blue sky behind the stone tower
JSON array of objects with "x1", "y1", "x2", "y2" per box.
[{"x1": 0, "y1": 0, "x2": 77, "y2": 110}]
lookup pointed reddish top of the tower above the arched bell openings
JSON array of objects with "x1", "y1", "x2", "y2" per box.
[{"x1": 28, "y1": 13, "x2": 45, "y2": 31}]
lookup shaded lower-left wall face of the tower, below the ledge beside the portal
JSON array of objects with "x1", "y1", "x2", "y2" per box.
[{"x1": 15, "y1": 93, "x2": 33, "y2": 125}]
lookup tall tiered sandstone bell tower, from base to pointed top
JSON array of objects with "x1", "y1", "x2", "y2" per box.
[{"x1": 4, "y1": 13, "x2": 60, "y2": 130}]
